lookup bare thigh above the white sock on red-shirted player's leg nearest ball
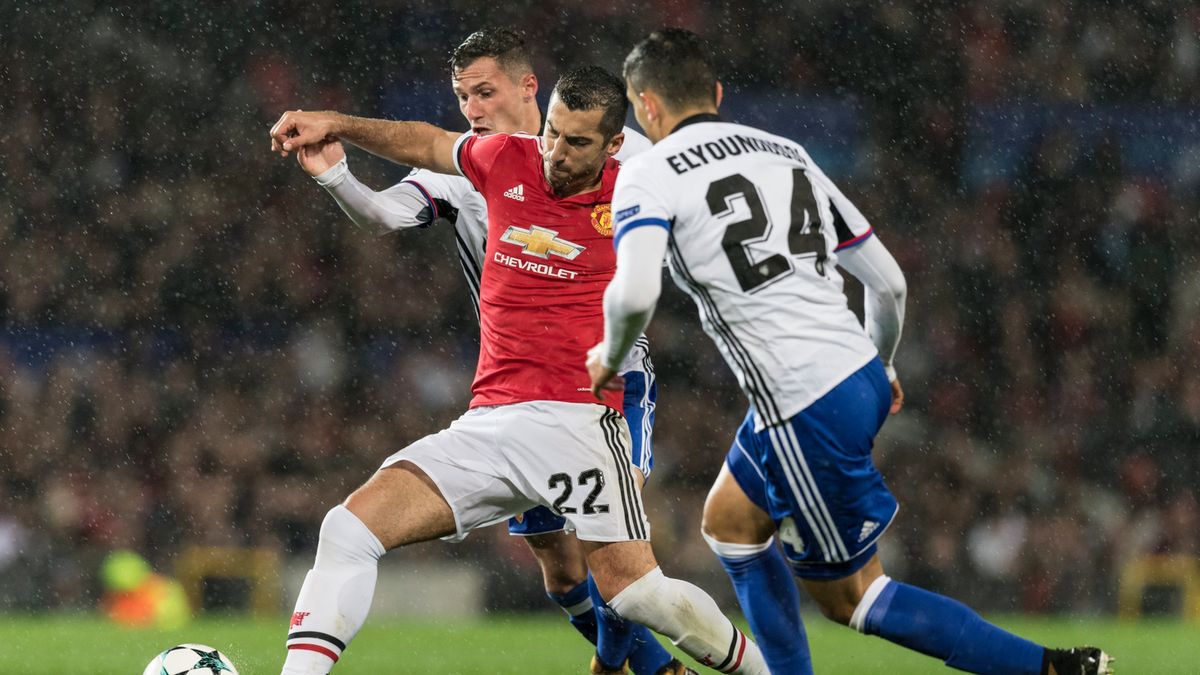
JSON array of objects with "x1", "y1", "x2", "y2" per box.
[{"x1": 346, "y1": 461, "x2": 455, "y2": 549}]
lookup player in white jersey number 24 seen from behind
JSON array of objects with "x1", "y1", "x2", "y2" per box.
[{"x1": 588, "y1": 29, "x2": 1110, "y2": 675}]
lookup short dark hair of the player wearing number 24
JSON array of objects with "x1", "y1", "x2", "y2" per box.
[{"x1": 623, "y1": 28, "x2": 716, "y2": 110}]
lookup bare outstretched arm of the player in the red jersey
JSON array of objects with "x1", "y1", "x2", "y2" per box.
[{"x1": 271, "y1": 110, "x2": 462, "y2": 174}]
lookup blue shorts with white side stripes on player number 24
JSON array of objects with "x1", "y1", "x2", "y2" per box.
[{"x1": 726, "y1": 359, "x2": 898, "y2": 579}]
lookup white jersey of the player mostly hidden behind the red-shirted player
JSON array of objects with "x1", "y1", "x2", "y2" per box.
[{"x1": 380, "y1": 126, "x2": 652, "y2": 372}]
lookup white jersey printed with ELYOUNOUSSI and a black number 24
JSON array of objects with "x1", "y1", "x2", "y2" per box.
[{"x1": 612, "y1": 115, "x2": 878, "y2": 430}]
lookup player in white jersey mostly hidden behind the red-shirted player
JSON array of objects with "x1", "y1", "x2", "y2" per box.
[{"x1": 296, "y1": 28, "x2": 686, "y2": 675}]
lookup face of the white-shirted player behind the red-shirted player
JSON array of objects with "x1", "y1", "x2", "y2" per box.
[{"x1": 452, "y1": 56, "x2": 533, "y2": 135}]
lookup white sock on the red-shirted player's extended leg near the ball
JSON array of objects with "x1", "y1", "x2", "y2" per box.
[{"x1": 283, "y1": 506, "x2": 385, "y2": 675}]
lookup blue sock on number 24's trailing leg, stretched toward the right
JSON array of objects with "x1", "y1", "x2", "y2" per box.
[{"x1": 851, "y1": 577, "x2": 1045, "y2": 675}]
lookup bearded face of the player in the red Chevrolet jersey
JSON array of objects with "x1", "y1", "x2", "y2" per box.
[{"x1": 541, "y1": 96, "x2": 625, "y2": 197}]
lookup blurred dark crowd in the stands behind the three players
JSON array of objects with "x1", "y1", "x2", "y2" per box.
[{"x1": 0, "y1": 0, "x2": 1200, "y2": 611}]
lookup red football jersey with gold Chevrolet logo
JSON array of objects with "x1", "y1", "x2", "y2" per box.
[{"x1": 455, "y1": 133, "x2": 623, "y2": 412}]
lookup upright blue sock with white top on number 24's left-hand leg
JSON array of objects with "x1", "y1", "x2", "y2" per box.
[{"x1": 706, "y1": 537, "x2": 812, "y2": 675}]
